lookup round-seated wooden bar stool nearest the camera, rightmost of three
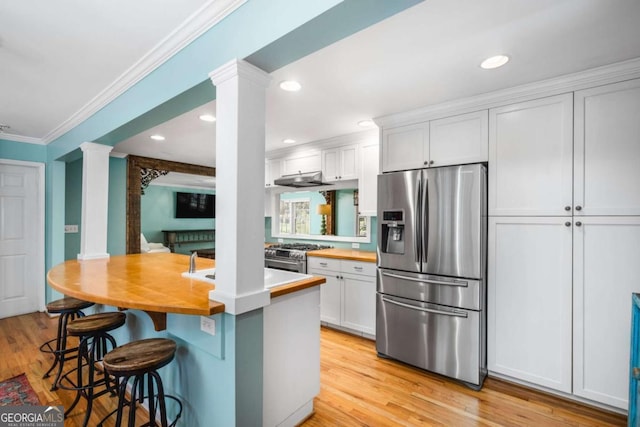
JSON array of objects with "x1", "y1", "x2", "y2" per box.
[{"x1": 98, "y1": 338, "x2": 182, "y2": 427}]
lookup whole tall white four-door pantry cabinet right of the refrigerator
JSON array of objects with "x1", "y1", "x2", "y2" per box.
[{"x1": 488, "y1": 80, "x2": 640, "y2": 409}]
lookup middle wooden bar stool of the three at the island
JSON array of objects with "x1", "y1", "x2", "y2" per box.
[{"x1": 58, "y1": 312, "x2": 127, "y2": 426}]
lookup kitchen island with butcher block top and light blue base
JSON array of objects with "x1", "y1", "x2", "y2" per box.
[{"x1": 47, "y1": 253, "x2": 325, "y2": 426}]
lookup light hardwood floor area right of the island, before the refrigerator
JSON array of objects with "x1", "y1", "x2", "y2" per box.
[{"x1": 304, "y1": 328, "x2": 626, "y2": 427}]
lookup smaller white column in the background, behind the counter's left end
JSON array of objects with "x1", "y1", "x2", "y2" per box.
[{"x1": 78, "y1": 142, "x2": 113, "y2": 260}]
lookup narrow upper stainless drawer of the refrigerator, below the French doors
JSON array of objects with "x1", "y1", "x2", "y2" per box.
[{"x1": 377, "y1": 268, "x2": 485, "y2": 310}]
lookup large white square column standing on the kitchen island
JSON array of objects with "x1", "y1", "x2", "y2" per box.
[{"x1": 209, "y1": 59, "x2": 271, "y2": 314}]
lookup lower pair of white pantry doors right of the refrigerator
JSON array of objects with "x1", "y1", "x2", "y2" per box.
[{"x1": 487, "y1": 216, "x2": 640, "y2": 409}]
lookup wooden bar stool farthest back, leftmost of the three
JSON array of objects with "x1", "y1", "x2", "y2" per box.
[{"x1": 40, "y1": 297, "x2": 93, "y2": 391}]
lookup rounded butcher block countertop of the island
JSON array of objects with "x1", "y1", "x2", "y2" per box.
[{"x1": 47, "y1": 253, "x2": 324, "y2": 331}]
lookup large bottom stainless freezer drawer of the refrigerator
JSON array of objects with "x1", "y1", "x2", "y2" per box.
[{"x1": 376, "y1": 294, "x2": 486, "y2": 385}]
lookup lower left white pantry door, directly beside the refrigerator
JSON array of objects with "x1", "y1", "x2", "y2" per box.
[{"x1": 487, "y1": 217, "x2": 572, "y2": 393}]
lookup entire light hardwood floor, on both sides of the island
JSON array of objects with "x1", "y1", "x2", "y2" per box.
[{"x1": 0, "y1": 313, "x2": 626, "y2": 427}]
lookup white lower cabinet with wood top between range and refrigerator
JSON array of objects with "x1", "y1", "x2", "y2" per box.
[{"x1": 307, "y1": 257, "x2": 376, "y2": 336}]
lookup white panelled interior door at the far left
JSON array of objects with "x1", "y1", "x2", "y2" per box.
[{"x1": 0, "y1": 160, "x2": 44, "y2": 318}]
